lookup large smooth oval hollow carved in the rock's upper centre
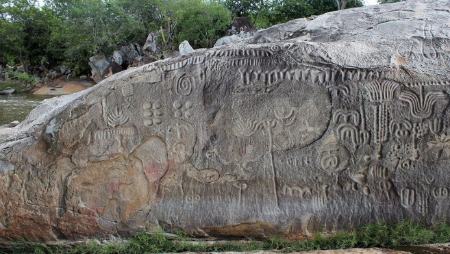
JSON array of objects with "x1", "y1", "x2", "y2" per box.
[{"x1": 231, "y1": 80, "x2": 331, "y2": 151}]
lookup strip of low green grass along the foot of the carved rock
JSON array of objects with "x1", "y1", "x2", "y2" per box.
[{"x1": 0, "y1": 221, "x2": 450, "y2": 254}]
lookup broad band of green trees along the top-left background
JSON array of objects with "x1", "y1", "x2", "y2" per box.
[{"x1": 0, "y1": 0, "x2": 231, "y2": 74}]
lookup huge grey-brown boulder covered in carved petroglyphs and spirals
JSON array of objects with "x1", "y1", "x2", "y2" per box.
[{"x1": 0, "y1": 0, "x2": 450, "y2": 241}]
